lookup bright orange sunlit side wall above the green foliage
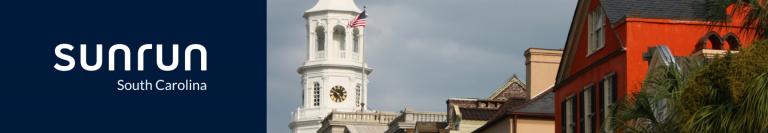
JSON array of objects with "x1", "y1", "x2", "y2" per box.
[{"x1": 626, "y1": 18, "x2": 753, "y2": 92}]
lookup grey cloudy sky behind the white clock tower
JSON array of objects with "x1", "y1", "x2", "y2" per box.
[{"x1": 267, "y1": 0, "x2": 576, "y2": 133}]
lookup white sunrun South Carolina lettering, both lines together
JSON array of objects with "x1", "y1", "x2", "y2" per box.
[{"x1": 53, "y1": 43, "x2": 208, "y2": 92}]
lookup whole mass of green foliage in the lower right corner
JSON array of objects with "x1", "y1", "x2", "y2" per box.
[{"x1": 610, "y1": 41, "x2": 768, "y2": 133}]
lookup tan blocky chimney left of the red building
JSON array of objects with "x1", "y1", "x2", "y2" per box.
[{"x1": 525, "y1": 48, "x2": 563, "y2": 98}]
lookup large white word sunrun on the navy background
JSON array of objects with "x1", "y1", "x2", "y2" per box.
[{"x1": 53, "y1": 43, "x2": 208, "y2": 71}]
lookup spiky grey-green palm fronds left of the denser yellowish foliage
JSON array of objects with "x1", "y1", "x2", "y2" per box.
[{"x1": 609, "y1": 62, "x2": 685, "y2": 133}]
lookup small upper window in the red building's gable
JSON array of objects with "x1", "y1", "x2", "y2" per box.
[{"x1": 587, "y1": 7, "x2": 605, "y2": 56}]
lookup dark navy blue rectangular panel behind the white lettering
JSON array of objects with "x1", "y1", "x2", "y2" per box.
[{"x1": 0, "y1": 0, "x2": 266, "y2": 132}]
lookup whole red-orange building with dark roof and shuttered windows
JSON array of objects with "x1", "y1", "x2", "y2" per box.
[{"x1": 553, "y1": 0, "x2": 753, "y2": 133}]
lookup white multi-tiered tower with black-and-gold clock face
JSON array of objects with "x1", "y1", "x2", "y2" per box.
[{"x1": 289, "y1": 0, "x2": 372, "y2": 133}]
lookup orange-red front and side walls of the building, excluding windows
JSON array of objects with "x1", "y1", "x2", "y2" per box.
[{"x1": 554, "y1": 0, "x2": 753, "y2": 132}]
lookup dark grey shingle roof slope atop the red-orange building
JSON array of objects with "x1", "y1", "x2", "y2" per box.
[{"x1": 600, "y1": 0, "x2": 709, "y2": 24}]
